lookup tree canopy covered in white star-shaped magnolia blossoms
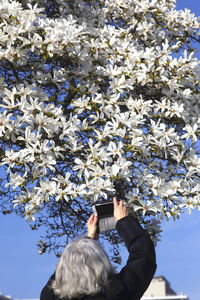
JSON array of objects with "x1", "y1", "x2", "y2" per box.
[{"x1": 0, "y1": 0, "x2": 200, "y2": 253}]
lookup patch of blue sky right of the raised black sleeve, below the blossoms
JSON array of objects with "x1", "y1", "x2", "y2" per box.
[{"x1": 156, "y1": 211, "x2": 200, "y2": 300}]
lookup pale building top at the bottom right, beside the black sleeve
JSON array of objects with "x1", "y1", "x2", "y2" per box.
[{"x1": 141, "y1": 276, "x2": 189, "y2": 300}]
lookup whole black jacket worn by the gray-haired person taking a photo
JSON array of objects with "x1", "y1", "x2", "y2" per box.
[{"x1": 40, "y1": 216, "x2": 156, "y2": 300}]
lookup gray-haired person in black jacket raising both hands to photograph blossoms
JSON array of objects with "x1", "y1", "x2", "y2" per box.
[{"x1": 40, "y1": 197, "x2": 156, "y2": 300}]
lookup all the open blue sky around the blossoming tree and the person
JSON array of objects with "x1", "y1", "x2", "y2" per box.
[{"x1": 0, "y1": 0, "x2": 200, "y2": 300}]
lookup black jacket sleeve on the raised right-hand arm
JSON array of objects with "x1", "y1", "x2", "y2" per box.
[{"x1": 116, "y1": 216, "x2": 156, "y2": 300}]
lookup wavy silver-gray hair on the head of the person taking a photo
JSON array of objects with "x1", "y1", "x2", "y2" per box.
[{"x1": 52, "y1": 237, "x2": 114, "y2": 299}]
